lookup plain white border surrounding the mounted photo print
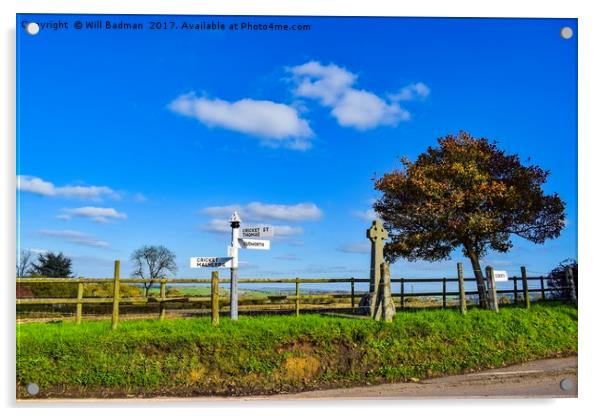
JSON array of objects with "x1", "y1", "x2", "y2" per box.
[{"x1": 0, "y1": 0, "x2": 602, "y2": 416}]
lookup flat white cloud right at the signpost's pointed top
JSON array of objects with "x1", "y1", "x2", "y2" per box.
[{"x1": 200, "y1": 202, "x2": 322, "y2": 222}]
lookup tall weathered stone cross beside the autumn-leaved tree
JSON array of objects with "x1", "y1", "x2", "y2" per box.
[{"x1": 366, "y1": 220, "x2": 395, "y2": 322}]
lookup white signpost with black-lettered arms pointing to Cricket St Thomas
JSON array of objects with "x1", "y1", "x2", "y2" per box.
[{"x1": 190, "y1": 211, "x2": 274, "y2": 320}]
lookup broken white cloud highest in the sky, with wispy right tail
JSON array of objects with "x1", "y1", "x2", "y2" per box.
[{"x1": 288, "y1": 61, "x2": 422, "y2": 130}]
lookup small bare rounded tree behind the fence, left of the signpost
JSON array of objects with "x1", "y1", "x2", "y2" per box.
[{"x1": 131, "y1": 246, "x2": 178, "y2": 297}]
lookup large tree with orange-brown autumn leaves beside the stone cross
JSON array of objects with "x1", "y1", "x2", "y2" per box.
[{"x1": 374, "y1": 132, "x2": 565, "y2": 304}]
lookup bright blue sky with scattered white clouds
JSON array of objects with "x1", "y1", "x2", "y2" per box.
[{"x1": 17, "y1": 15, "x2": 577, "y2": 286}]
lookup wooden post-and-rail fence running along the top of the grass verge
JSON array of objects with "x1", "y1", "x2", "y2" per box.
[{"x1": 17, "y1": 261, "x2": 576, "y2": 329}]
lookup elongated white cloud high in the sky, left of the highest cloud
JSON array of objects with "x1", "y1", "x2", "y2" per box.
[{"x1": 169, "y1": 93, "x2": 314, "y2": 150}]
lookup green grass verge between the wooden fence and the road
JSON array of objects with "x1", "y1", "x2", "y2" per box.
[{"x1": 17, "y1": 304, "x2": 577, "y2": 397}]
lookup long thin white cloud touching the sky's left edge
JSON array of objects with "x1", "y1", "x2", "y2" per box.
[{"x1": 17, "y1": 175, "x2": 118, "y2": 200}]
